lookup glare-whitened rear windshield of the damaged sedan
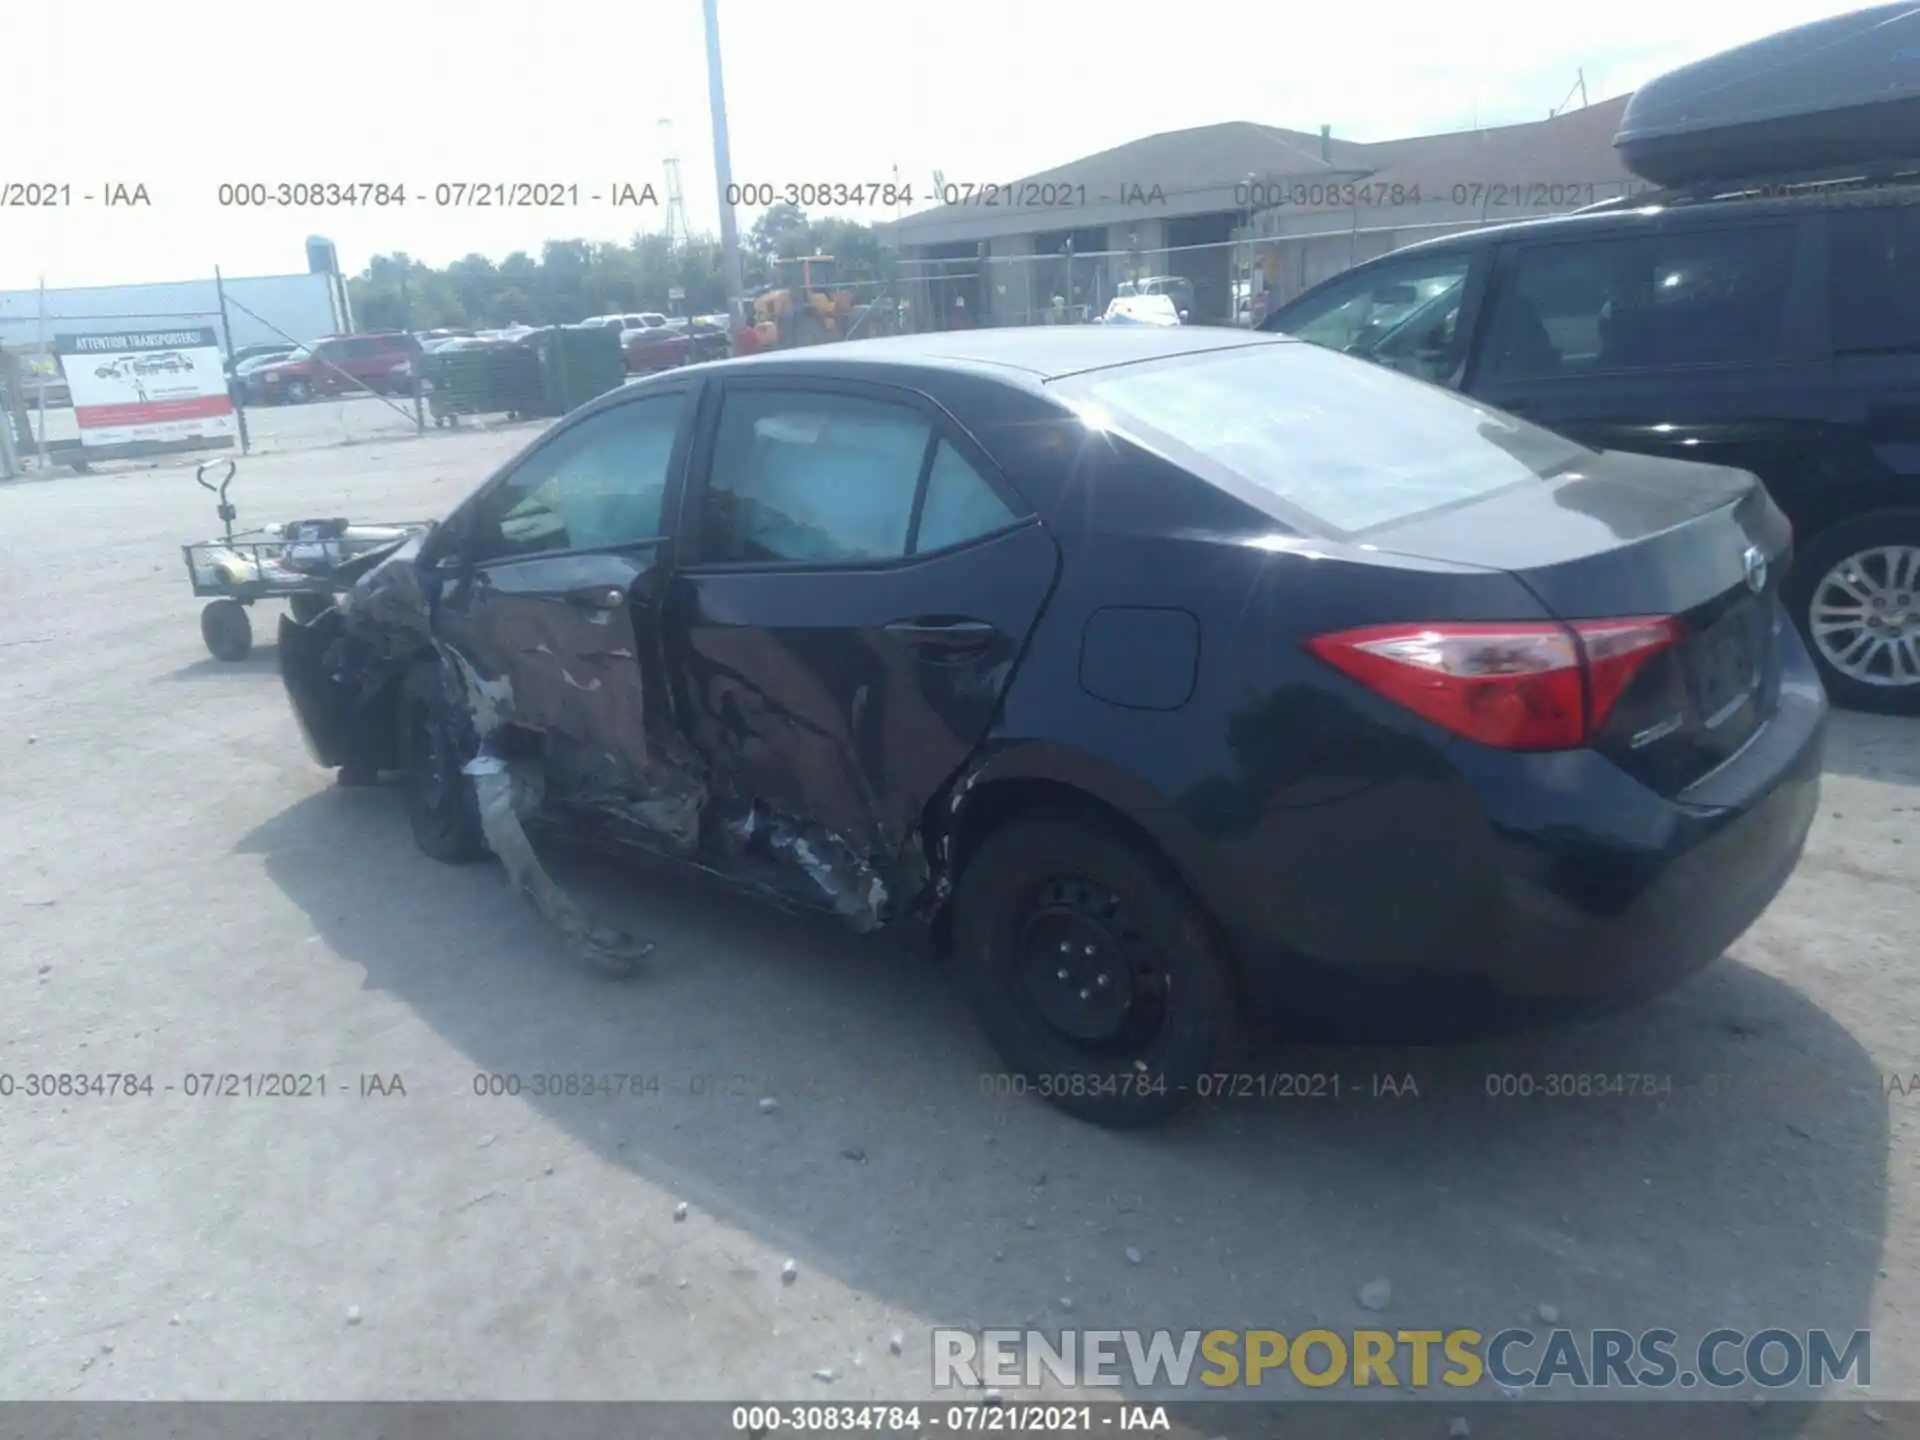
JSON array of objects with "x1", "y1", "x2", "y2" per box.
[{"x1": 1054, "y1": 342, "x2": 1594, "y2": 534}]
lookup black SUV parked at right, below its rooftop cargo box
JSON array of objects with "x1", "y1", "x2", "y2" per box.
[{"x1": 1260, "y1": 175, "x2": 1920, "y2": 714}]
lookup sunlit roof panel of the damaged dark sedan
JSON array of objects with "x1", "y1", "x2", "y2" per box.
[{"x1": 699, "y1": 324, "x2": 1298, "y2": 382}]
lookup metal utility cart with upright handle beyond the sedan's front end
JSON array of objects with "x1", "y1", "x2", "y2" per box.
[{"x1": 180, "y1": 461, "x2": 430, "y2": 660}]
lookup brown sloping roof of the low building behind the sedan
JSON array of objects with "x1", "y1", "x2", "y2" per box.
[{"x1": 877, "y1": 96, "x2": 1630, "y2": 246}]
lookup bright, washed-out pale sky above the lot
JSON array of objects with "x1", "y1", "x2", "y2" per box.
[{"x1": 0, "y1": 0, "x2": 1859, "y2": 290}]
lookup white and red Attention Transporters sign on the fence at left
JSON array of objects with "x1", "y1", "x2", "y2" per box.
[{"x1": 54, "y1": 326, "x2": 234, "y2": 449}]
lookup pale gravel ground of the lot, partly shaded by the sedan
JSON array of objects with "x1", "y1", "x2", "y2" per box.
[{"x1": 0, "y1": 437, "x2": 1920, "y2": 1432}]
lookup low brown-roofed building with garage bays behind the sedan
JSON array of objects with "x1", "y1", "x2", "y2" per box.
[{"x1": 879, "y1": 96, "x2": 1634, "y2": 324}]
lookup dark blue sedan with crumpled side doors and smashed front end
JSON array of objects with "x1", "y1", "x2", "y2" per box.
[{"x1": 280, "y1": 326, "x2": 1826, "y2": 1123}]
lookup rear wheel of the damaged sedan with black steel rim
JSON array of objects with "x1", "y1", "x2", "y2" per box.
[{"x1": 952, "y1": 812, "x2": 1242, "y2": 1127}]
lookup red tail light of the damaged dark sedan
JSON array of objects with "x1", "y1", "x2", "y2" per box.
[{"x1": 1308, "y1": 616, "x2": 1680, "y2": 751}]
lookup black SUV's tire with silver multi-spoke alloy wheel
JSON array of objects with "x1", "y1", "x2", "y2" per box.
[{"x1": 1784, "y1": 511, "x2": 1920, "y2": 714}]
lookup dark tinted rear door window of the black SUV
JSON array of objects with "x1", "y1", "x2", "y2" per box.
[{"x1": 1480, "y1": 225, "x2": 1793, "y2": 380}]
